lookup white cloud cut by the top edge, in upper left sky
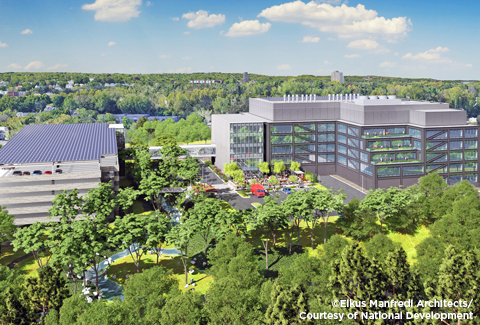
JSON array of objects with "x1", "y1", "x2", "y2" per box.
[{"x1": 82, "y1": 0, "x2": 142, "y2": 22}]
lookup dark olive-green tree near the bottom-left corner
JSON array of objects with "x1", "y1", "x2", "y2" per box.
[{"x1": 21, "y1": 265, "x2": 69, "y2": 318}]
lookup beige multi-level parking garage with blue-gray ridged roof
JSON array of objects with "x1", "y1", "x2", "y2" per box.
[{"x1": 0, "y1": 123, "x2": 124, "y2": 225}]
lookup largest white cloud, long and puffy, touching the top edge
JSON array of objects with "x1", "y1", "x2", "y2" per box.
[{"x1": 257, "y1": 0, "x2": 411, "y2": 41}]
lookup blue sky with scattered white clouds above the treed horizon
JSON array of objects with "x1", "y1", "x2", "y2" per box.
[{"x1": 0, "y1": 0, "x2": 480, "y2": 80}]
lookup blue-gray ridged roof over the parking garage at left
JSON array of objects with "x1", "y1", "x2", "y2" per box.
[{"x1": 0, "y1": 123, "x2": 117, "y2": 164}]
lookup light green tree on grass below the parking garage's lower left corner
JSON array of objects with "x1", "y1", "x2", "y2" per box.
[{"x1": 12, "y1": 221, "x2": 53, "y2": 268}]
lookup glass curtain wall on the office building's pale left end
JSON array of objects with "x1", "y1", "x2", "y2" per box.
[{"x1": 230, "y1": 123, "x2": 264, "y2": 171}]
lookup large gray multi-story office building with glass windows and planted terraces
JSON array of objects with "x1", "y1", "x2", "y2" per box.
[{"x1": 212, "y1": 95, "x2": 479, "y2": 189}]
